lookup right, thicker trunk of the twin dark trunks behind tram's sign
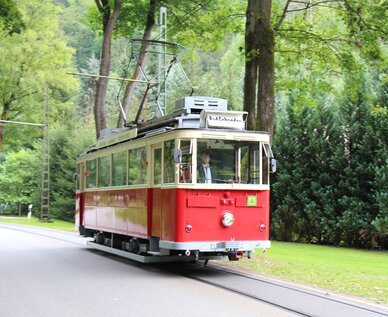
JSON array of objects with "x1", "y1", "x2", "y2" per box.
[{"x1": 256, "y1": 0, "x2": 275, "y2": 137}]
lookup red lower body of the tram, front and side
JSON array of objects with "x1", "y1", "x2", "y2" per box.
[{"x1": 77, "y1": 188, "x2": 269, "y2": 242}]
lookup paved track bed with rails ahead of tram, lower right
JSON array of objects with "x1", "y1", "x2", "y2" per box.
[{"x1": 177, "y1": 264, "x2": 388, "y2": 317}]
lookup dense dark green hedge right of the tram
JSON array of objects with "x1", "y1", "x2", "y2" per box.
[{"x1": 272, "y1": 76, "x2": 388, "y2": 248}]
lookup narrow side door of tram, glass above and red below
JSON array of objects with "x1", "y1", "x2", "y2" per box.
[{"x1": 151, "y1": 144, "x2": 162, "y2": 237}]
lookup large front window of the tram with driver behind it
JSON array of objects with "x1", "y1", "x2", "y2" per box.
[{"x1": 197, "y1": 139, "x2": 268, "y2": 184}]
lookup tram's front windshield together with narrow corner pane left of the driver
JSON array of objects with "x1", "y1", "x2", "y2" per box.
[{"x1": 180, "y1": 139, "x2": 272, "y2": 184}]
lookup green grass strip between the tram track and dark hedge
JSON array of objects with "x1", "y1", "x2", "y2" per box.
[{"x1": 224, "y1": 242, "x2": 388, "y2": 304}]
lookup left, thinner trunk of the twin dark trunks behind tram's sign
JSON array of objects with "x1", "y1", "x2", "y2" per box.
[{"x1": 244, "y1": 0, "x2": 259, "y2": 130}]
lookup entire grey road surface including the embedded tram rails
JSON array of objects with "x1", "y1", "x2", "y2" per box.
[{"x1": 0, "y1": 223, "x2": 388, "y2": 317}]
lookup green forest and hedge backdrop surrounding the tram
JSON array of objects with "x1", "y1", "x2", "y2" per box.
[{"x1": 0, "y1": 0, "x2": 388, "y2": 249}]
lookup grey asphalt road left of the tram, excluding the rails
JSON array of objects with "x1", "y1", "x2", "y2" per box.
[{"x1": 0, "y1": 226, "x2": 293, "y2": 317}]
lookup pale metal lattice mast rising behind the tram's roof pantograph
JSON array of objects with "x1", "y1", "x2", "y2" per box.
[{"x1": 157, "y1": 7, "x2": 167, "y2": 115}]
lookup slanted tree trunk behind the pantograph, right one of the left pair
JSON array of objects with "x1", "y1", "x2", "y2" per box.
[{"x1": 117, "y1": 0, "x2": 159, "y2": 128}]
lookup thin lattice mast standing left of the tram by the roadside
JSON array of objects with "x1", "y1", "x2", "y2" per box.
[{"x1": 40, "y1": 85, "x2": 50, "y2": 221}]
